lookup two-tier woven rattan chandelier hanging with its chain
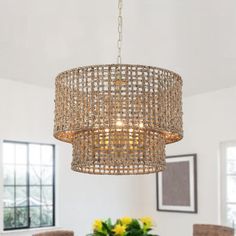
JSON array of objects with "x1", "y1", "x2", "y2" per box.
[{"x1": 54, "y1": 0, "x2": 183, "y2": 175}]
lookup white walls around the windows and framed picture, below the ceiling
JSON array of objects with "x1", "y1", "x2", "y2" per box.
[{"x1": 0, "y1": 77, "x2": 236, "y2": 236}]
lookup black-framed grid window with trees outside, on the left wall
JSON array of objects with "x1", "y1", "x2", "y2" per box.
[{"x1": 3, "y1": 141, "x2": 55, "y2": 230}]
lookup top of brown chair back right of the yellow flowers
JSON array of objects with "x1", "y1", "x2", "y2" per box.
[{"x1": 193, "y1": 224, "x2": 234, "y2": 236}]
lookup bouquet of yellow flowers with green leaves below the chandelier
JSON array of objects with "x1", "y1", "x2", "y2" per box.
[{"x1": 88, "y1": 217, "x2": 158, "y2": 236}]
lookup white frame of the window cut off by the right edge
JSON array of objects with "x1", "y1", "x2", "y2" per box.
[{"x1": 220, "y1": 141, "x2": 236, "y2": 228}]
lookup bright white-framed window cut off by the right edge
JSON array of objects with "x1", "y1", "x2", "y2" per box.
[{"x1": 221, "y1": 142, "x2": 236, "y2": 227}]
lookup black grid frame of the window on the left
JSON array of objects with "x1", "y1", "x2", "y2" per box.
[{"x1": 0, "y1": 139, "x2": 56, "y2": 232}]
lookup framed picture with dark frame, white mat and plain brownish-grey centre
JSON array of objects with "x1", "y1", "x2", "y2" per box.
[{"x1": 156, "y1": 154, "x2": 197, "y2": 213}]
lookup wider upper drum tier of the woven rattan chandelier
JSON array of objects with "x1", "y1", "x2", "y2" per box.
[{"x1": 54, "y1": 64, "x2": 183, "y2": 143}]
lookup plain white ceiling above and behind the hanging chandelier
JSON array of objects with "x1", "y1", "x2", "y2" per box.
[{"x1": 0, "y1": 0, "x2": 236, "y2": 96}]
